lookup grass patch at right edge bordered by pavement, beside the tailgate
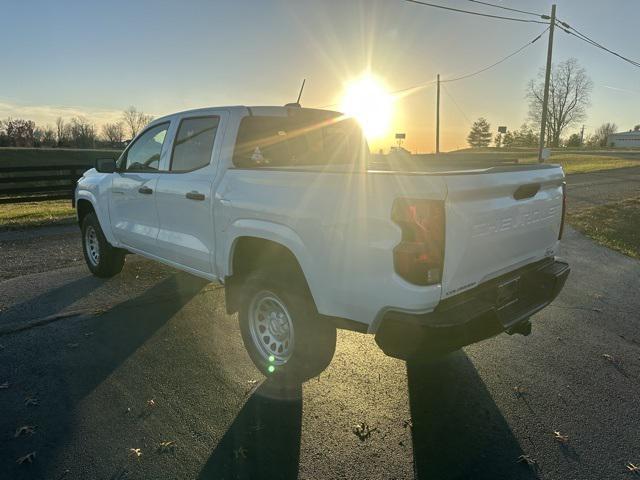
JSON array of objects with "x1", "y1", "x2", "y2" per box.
[{"x1": 567, "y1": 197, "x2": 640, "y2": 259}]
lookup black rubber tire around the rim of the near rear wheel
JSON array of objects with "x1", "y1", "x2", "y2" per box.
[{"x1": 238, "y1": 272, "x2": 336, "y2": 389}]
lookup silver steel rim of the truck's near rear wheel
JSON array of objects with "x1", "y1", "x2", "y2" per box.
[{"x1": 249, "y1": 291, "x2": 294, "y2": 367}]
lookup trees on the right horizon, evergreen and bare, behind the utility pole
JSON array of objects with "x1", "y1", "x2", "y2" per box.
[{"x1": 467, "y1": 58, "x2": 640, "y2": 148}]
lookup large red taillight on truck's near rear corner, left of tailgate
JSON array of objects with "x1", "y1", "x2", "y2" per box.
[{"x1": 391, "y1": 198, "x2": 444, "y2": 285}]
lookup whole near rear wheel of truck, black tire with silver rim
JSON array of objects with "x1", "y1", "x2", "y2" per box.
[{"x1": 239, "y1": 274, "x2": 336, "y2": 387}]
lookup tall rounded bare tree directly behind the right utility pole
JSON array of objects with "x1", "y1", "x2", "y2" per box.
[{"x1": 527, "y1": 58, "x2": 593, "y2": 147}]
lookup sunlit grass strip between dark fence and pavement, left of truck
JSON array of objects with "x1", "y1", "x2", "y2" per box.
[{"x1": 0, "y1": 200, "x2": 75, "y2": 230}]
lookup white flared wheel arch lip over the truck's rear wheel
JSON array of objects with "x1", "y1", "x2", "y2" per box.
[{"x1": 217, "y1": 219, "x2": 327, "y2": 313}]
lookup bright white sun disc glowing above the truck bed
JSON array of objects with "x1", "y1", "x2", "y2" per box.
[{"x1": 340, "y1": 74, "x2": 393, "y2": 140}]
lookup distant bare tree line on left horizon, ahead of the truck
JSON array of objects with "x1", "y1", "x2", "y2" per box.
[{"x1": 0, "y1": 106, "x2": 153, "y2": 148}]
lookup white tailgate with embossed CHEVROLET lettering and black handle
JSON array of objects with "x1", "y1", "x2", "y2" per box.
[{"x1": 442, "y1": 165, "x2": 564, "y2": 298}]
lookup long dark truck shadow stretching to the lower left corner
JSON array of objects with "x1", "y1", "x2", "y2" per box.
[{"x1": 0, "y1": 274, "x2": 206, "y2": 479}]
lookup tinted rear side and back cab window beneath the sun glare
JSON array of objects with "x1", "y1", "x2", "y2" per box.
[{"x1": 233, "y1": 108, "x2": 368, "y2": 169}]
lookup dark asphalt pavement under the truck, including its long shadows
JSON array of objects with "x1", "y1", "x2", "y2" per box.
[{"x1": 0, "y1": 171, "x2": 640, "y2": 480}]
